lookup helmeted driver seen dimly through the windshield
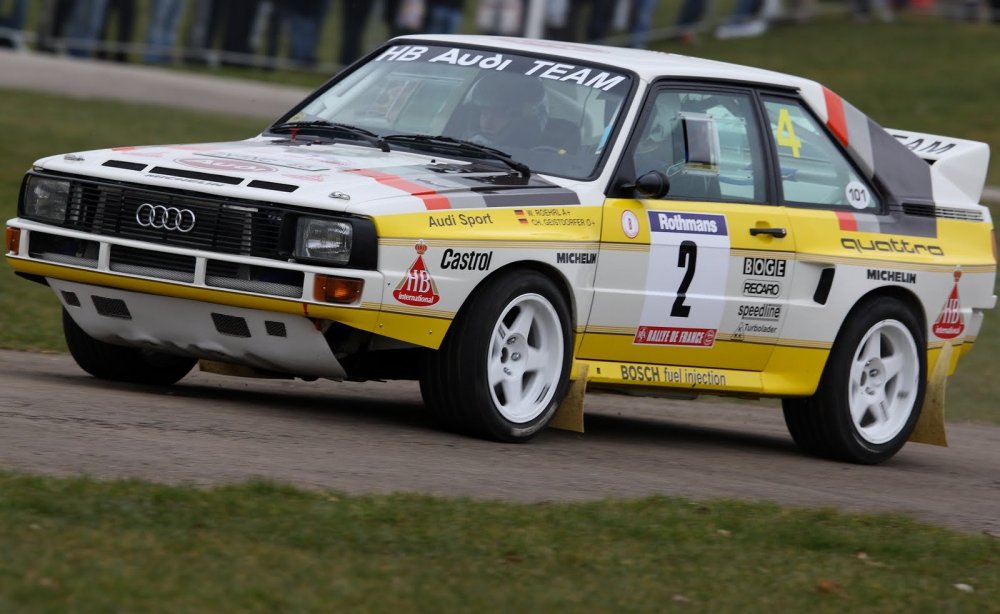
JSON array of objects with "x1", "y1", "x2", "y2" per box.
[{"x1": 466, "y1": 72, "x2": 548, "y2": 149}]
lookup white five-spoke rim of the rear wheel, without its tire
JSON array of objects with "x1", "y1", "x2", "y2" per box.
[{"x1": 848, "y1": 320, "x2": 920, "y2": 444}]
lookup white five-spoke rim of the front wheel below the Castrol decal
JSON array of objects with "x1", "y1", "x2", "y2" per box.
[{"x1": 486, "y1": 294, "x2": 566, "y2": 424}]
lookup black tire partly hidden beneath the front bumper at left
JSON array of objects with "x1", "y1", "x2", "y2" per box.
[{"x1": 63, "y1": 309, "x2": 198, "y2": 386}]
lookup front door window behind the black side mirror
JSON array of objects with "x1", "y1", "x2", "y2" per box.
[{"x1": 632, "y1": 88, "x2": 766, "y2": 203}]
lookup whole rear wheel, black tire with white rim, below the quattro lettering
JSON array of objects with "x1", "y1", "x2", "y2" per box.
[{"x1": 783, "y1": 297, "x2": 927, "y2": 465}]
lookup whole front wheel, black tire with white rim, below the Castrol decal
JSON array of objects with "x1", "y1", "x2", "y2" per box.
[{"x1": 421, "y1": 270, "x2": 572, "y2": 443}]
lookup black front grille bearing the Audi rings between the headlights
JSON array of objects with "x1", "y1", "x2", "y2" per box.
[{"x1": 66, "y1": 181, "x2": 287, "y2": 259}]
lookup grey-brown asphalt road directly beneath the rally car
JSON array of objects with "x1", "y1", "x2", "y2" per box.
[{"x1": 0, "y1": 351, "x2": 1000, "y2": 534}]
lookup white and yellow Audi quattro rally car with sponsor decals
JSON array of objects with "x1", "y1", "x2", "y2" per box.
[{"x1": 6, "y1": 36, "x2": 996, "y2": 463}]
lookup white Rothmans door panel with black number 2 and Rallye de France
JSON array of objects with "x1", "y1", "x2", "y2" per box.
[{"x1": 632, "y1": 211, "x2": 729, "y2": 347}]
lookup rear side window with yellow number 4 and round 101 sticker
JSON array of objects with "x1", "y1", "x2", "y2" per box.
[{"x1": 764, "y1": 97, "x2": 879, "y2": 210}]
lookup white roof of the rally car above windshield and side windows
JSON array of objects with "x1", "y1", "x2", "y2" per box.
[{"x1": 402, "y1": 34, "x2": 812, "y2": 88}]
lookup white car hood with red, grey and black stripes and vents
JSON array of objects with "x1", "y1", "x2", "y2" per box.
[{"x1": 35, "y1": 137, "x2": 579, "y2": 215}]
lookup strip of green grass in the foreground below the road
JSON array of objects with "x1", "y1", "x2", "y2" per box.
[{"x1": 0, "y1": 473, "x2": 1000, "y2": 612}]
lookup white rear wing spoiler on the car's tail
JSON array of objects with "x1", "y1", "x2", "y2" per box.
[{"x1": 887, "y1": 128, "x2": 990, "y2": 203}]
